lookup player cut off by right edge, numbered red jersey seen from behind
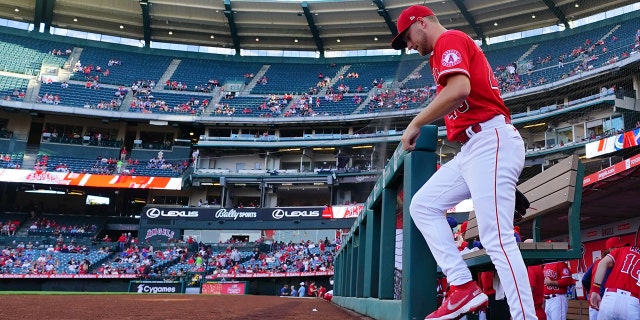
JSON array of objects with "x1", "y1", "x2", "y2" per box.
[{"x1": 589, "y1": 241, "x2": 640, "y2": 320}]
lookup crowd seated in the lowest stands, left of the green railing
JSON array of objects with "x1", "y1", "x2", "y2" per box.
[{"x1": 0, "y1": 228, "x2": 340, "y2": 278}]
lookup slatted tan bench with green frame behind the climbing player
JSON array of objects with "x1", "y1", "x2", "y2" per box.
[{"x1": 463, "y1": 155, "x2": 584, "y2": 273}]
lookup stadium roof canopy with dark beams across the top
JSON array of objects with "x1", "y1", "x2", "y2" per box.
[{"x1": 0, "y1": 0, "x2": 637, "y2": 52}]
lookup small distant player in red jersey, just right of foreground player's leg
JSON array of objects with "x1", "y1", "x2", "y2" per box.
[{"x1": 542, "y1": 261, "x2": 573, "y2": 320}]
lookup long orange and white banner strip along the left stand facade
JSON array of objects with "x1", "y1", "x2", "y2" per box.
[{"x1": 0, "y1": 169, "x2": 182, "y2": 190}]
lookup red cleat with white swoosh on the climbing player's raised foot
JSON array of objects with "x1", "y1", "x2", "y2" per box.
[{"x1": 425, "y1": 281, "x2": 489, "y2": 320}]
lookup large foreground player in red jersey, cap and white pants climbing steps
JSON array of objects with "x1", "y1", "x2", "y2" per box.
[{"x1": 391, "y1": 5, "x2": 536, "y2": 320}]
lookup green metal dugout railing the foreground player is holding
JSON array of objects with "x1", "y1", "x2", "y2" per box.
[{"x1": 332, "y1": 125, "x2": 438, "y2": 320}]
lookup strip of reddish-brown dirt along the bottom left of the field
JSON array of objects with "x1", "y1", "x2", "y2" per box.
[{"x1": 0, "y1": 294, "x2": 370, "y2": 320}]
